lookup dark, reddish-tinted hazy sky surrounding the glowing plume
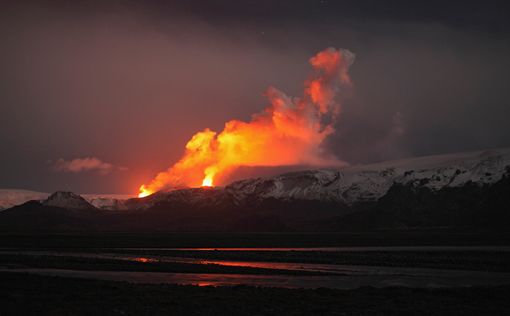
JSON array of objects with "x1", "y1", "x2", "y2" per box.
[{"x1": 0, "y1": 0, "x2": 510, "y2": 193}]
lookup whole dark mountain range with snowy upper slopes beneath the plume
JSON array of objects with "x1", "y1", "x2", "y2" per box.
[{"x1": 0, "y1": 149, "x2": 510, "y2": 231}]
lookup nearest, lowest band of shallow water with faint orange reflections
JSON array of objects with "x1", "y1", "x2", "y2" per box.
[{"x1": 0, "y1": 269, "x2": 510, "y2": 289}]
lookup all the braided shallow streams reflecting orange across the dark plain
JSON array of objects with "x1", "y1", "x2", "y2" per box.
[{"x1": 0, "y1": 247, "x2": 510, "y2": 289}]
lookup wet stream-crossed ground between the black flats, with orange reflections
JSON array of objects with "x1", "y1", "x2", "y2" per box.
[{"x1": 0, "y1": 246, "x2": 510, "y2": 289}]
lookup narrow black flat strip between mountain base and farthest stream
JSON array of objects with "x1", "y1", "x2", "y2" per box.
[{"x1": 0, "y1": 230, "x2": 510, "y2": 249}]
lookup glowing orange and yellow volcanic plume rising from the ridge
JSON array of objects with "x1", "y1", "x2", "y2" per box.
[{"x1": 139, "y1": 48, "x2": 354, "y2": 197}]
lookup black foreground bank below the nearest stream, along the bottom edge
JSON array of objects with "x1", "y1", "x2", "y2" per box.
[{"x1": 0, "y1": 272, "x2": 510, "y2": 315}]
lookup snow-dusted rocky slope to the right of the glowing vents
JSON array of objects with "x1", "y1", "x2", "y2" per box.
[{"x1": 226, "y1": 148, "x2": 510, "y2": 204}]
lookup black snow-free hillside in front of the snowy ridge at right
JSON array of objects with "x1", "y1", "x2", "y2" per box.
[{"x1": 330, "y1": 172, "x2": 510, "y2": 231}]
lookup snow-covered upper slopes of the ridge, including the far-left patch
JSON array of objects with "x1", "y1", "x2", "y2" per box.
[{"x1": 0, "y1": 148, "x2": 510, "y2": 210}]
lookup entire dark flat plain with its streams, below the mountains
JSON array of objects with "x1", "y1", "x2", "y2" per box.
[{"x1": 0, "y1": 231, "x2": 510, "y2": 316}]
